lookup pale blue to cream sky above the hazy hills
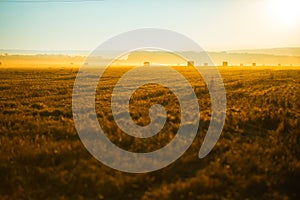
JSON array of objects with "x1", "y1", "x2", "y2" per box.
[{"x1": 0, "y1": 0, "x2": 300, "y2": 51}]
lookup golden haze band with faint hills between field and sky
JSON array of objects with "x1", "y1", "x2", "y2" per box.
[{"x1": 0, "y1": 48, "x2": 300, "y2": 67}]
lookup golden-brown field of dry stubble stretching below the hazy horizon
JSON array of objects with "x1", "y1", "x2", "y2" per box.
[{"x1": 0, "y1": 67, "x2": 300, "y2": 200}]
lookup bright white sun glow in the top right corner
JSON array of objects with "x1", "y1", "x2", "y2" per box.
[{"x1": 268, "y1": 0, "x2": 300, "y2": 26}]
